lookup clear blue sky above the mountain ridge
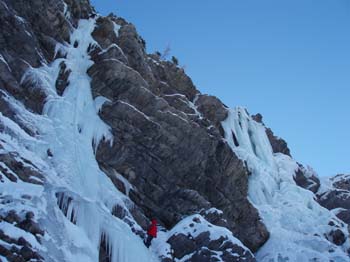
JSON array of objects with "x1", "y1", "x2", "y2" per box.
[{"x1": 91, "y1": 0, "x2": 350, "y2": 176}]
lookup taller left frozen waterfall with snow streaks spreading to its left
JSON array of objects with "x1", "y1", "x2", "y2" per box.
[{"x1": 0, "y1": 19, "x2": 158, "y2": 262}]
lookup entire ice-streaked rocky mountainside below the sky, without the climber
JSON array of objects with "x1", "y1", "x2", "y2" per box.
[{"x1": 0, "y1": 0, "x2": 350, "y2": 262}]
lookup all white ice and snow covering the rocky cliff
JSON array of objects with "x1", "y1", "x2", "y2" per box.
[{"x1": 0, "y1": 7, "x2": 350, "y2": 262}]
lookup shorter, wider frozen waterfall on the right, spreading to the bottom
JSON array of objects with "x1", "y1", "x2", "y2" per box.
[{"x1": 222, "y1": 108, "x2": 350, "y2": 261}]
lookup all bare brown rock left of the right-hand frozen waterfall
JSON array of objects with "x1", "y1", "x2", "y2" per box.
[{"x1": 0, "y1": 0, "x2": 269, "y2": 261}]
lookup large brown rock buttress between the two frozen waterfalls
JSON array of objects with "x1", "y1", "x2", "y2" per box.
[{"x1": 88, "y1": 10, "x2": 268, "y2": 251}]
